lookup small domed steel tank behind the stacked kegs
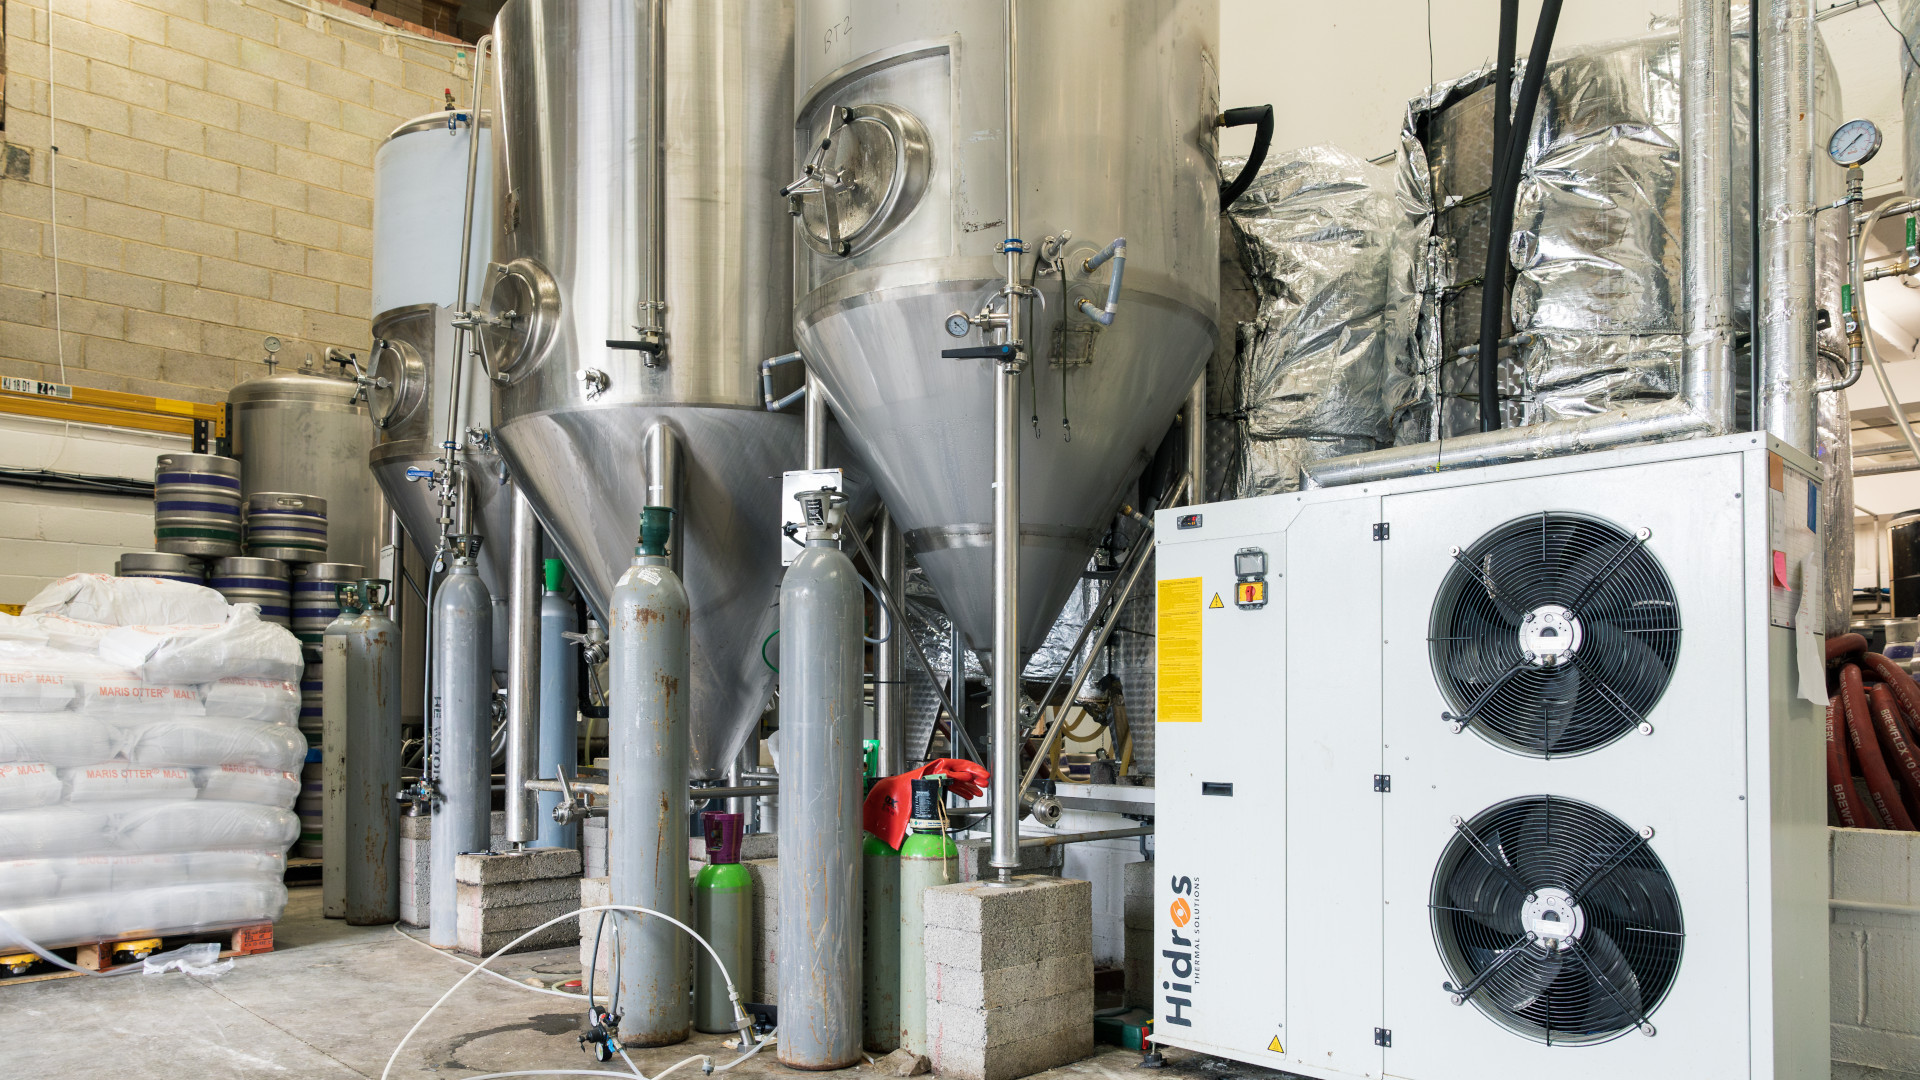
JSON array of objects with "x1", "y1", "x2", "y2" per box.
[{"x1": 227, "y1": 375, "x2": 386, "y2": 567}]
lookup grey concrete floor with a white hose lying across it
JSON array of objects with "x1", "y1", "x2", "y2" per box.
[{"x1": 0, "y1": 888, "x2": 1283, "y2": 1080}]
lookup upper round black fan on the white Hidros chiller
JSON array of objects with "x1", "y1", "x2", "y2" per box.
[{"x1": 1428, "y1": 513, "x2": 1680, "y2": 757}]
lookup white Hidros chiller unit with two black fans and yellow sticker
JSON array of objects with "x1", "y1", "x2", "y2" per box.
[{"x1": 1154, "y1": 434, "x2": 1828, "y2": 1080}]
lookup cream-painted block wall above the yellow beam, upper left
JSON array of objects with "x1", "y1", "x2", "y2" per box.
[{"x1": 0, "y1": 0, "x2": 468, "y2": 402}]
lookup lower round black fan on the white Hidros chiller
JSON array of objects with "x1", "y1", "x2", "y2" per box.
[{"x1": 1430, "y1": 796, "x2": 1686, "y2": 1045}]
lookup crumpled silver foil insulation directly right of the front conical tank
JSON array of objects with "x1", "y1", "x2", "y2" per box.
[{"x1": 1219, "y1": 146, "x2": 1411, "y2": 498}]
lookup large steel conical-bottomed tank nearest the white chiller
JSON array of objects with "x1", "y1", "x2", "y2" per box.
[{"x1": 781, "y1": 0, "x2": 1213, "y2": 651}]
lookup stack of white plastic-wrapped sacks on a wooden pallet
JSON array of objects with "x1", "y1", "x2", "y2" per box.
[{"x1": 0, "y1": 575, "x2": 307, "y2": 945}]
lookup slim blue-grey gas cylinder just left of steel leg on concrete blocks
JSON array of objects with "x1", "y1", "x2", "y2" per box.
[{"x1": 428, "y1": 534, "x2": 495, "y2": 949}]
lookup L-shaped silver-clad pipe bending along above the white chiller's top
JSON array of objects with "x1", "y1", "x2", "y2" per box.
[{"x1": 1306, "y1": 0, "x2": 1734, "y2": 488}]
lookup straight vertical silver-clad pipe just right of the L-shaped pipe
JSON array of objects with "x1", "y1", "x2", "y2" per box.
[{"x1": 1755, "y1": 0, "x2": 1816, "y2": 455}]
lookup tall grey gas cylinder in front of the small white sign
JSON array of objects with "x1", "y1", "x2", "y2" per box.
[{"x1": 778, "y1": 492, "x2": 866, "y2": 1068}]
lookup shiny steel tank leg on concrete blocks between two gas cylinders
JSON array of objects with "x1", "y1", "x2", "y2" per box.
[{"x1": 507, "y1": 484, "x2": 540, "y2": 847}]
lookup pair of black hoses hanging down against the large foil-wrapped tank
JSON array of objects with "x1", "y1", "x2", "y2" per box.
[{"x1": 1478, "y1": 0, "x2": 1561, "y2": 430}]
